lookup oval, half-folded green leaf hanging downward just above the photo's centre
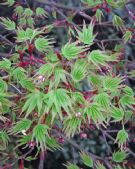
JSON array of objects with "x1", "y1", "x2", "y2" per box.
[{"x1": 71, "y1": 59, "x2": 88, "y2": 82}]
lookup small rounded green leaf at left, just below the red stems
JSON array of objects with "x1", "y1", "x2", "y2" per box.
[{"x1": 12, "y1": 67, "x2": 26, "y2": 82}]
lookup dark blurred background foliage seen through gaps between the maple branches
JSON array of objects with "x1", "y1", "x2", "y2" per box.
[{"x1": 0, "y1": 0, "x2": 135, "y2": 169}]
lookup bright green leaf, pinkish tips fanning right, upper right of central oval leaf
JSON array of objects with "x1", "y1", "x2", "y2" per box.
[{"x1": 88, "y1": 50, "x2": 110, "y2": 69}]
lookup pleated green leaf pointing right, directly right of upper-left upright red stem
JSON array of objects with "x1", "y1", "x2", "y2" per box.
[{"x1": 35, "y1": 38, "x2": 53, "y2": 52}]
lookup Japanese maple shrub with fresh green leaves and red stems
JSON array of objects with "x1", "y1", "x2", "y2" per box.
[{"x1": 0, "y1": 0, "x2": 135, "y2": 169}]
